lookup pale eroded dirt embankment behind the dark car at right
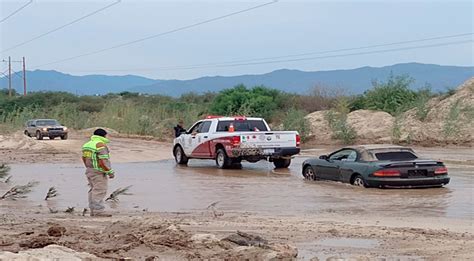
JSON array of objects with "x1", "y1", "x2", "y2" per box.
[{"x1": 306, "y1": 78, "x2": 474, "y2": 146}]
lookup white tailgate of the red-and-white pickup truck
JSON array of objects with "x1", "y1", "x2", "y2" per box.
[{"x1": 239, "y1": 131, "x2": 298, "y2": 148}]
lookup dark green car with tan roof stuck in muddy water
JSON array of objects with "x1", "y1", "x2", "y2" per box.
[{"x1": 303, "y1": 145, "x2": 450, "y2": 188}]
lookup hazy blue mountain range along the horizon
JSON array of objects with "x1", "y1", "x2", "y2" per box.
[{"x1": 0, "y1": 63, "x2": 474, "y2": 96}]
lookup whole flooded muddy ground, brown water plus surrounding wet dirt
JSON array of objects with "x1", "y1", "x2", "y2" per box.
[{"x1": 0, "y1": 135, "x2": 474, "y2": 260}]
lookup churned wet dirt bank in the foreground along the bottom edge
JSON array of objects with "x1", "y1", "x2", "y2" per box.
[{"x1": 0, "y1": 209, "x2": 474, "y2": 261}]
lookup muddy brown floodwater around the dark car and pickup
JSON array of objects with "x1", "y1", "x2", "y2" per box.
[{"x1": 0, "y1": 157, "x2": 474, "y2": 219}]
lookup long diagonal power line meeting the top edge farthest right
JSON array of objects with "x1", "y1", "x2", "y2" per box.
[{"x1": 33, "y1": 0, "x2": 278, "y2": 68}]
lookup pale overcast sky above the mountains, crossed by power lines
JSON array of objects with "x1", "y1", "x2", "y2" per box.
[{"x1": 0, "y1": 0, "x2": 474, "y2": 79}]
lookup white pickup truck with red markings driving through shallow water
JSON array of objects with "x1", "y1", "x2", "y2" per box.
[{"x1": 173, "y1": 116, "x2": 300, "y2": 169}]
